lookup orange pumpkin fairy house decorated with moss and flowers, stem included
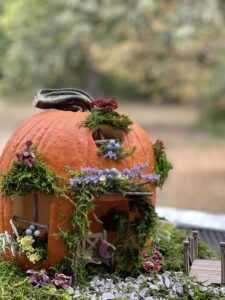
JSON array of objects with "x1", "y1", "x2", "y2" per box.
[{"x1": 0, "y1": 89, "x2": 171, "y2": 278}]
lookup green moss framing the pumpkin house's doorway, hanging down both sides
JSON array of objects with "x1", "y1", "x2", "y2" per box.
[{"x1": 59, "y1": 171, "x2": 156, "y2": 284}]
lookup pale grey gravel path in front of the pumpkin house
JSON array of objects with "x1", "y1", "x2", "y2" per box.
[{"x1": 71, "y1": 271, "x2": 225, "y2": 300}]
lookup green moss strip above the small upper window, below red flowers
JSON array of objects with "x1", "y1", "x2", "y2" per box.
[{"x1": 83, "y1": 109, "x2": 133, "y2": 132}]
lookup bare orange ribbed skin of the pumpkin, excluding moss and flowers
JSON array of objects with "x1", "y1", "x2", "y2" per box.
[{"x1": 0, "y1": 110, "x2": 155, "y2": 268}]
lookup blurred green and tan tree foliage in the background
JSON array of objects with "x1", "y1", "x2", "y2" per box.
[{"x1": 0, "y1": 0, "x2": 225, "y2": 115}]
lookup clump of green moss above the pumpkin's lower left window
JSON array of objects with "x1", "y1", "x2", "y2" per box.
[{"x1": 0, "y1": 149, "x2": 63, "y2": 196}]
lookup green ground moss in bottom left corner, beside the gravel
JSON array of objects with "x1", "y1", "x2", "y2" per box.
[{"x1": 0, "y1": 260, "x2": 71, "y2": 300}]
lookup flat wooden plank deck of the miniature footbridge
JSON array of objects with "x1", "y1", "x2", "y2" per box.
[{"x1": 190, "y1": 259, "x2": 221, "y2": 283}]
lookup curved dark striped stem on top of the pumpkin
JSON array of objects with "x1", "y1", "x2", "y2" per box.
[{"x1": 33, "y1": 88, "x2": 93, "y2": 111}]
